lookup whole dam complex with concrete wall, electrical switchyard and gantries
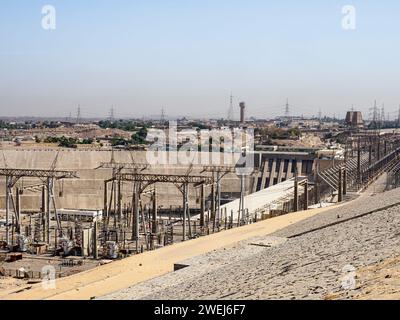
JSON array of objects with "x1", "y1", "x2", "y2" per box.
[{"x1": 0, "y1": 134, "x2": 400, "y2": 286}]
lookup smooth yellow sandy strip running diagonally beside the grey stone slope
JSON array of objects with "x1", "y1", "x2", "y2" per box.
[{"x1": 0, "y1": 202, "x2": 344, "y2": 300}]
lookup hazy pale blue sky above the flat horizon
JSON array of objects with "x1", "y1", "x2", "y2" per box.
[{"x1": 0, "y1": 0, "x2": 400, "y2": 117}]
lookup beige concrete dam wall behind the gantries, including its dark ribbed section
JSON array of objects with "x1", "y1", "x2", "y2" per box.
[{"x1": 0, "y1": 148, "x2": 314, "y2": 211}]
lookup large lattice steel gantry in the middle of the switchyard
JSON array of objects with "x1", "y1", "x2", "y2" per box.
[{"x1": 96, "y1": 152, "x2": 220, "y2": 252}]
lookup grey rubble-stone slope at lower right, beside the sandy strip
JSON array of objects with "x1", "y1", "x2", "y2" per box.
[{"x1": 104, "y1": 178, "x2": 400, "y2": 300}]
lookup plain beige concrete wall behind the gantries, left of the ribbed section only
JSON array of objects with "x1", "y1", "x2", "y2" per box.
[{"x1": 0, "y1": 149, "x2": 251, "y2": 210}]
